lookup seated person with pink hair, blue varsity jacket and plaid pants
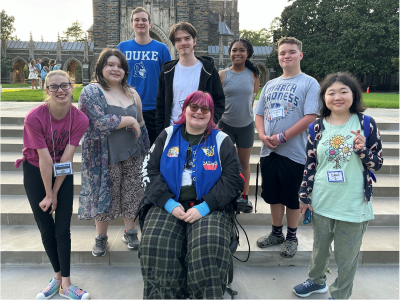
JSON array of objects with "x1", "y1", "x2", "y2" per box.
[{"x1": 139, "y1": 91, "x2": 244, "y2": 299}]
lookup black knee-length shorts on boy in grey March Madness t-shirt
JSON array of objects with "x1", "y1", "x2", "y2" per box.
[{"x1": 260, "y1": 152, "x2": 304, "y2": 209}]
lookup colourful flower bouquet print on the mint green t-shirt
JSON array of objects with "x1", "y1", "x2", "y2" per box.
[{"x1": 322, "y1": 134, "x2": 353, "y2": 169}]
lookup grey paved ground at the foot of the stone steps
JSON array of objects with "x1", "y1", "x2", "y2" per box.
[{"x1": 1, "y1": 266, "x2": 399, "y2": 299}]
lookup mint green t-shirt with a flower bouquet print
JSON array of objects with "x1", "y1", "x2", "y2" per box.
[{"x1": 312, "y1": 114, "x2": 374, "y2": 223}]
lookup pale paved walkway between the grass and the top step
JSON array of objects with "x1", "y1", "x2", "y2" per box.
[{"x1": 0, "y1": 102, "x2": 399, "y2": 122}]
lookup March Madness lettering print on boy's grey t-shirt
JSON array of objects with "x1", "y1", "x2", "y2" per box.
[{"x1": 264, "y1": 83, "x2": 300, "y2": 122}]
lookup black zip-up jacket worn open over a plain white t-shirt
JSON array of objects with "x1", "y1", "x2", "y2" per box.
[{"x1": 156, "y1": 56, "x2": 225, "y2": 136}]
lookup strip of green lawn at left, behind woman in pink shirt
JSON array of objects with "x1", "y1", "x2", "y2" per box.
[{"x1": 1, "y1": 87, "x2": 83, "y2": 102}]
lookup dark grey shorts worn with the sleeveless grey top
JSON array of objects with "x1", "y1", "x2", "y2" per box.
[{"x1": 218, "y1": 121, "x2": 254, "y2": 149}]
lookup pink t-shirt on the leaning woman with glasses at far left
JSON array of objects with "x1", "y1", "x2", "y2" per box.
[{"x1": 15, "y1": 103, "x2": 89, "y2": 168}]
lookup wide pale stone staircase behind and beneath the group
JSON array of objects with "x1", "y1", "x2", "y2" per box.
[{"x1": 0, "y1": 113, "x2": 399, "y2": 266}]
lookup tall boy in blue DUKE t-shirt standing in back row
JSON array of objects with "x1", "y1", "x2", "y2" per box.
[{"x1": 117, "y1": 7, "x2": 171, "y2": 144}]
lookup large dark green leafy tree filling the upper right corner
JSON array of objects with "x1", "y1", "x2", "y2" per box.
[{"x1": 271, "y1": 0, "x2": 399, "y2": 79}]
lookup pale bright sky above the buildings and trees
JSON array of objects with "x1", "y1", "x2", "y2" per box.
[{"x1": 0, "y1": 0, "x2": 288, "y2": 42}]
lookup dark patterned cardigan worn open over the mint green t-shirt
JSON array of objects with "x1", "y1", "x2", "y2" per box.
[{"x1": 299, "y1": 113, "x2": 383, "y2": 204}]
